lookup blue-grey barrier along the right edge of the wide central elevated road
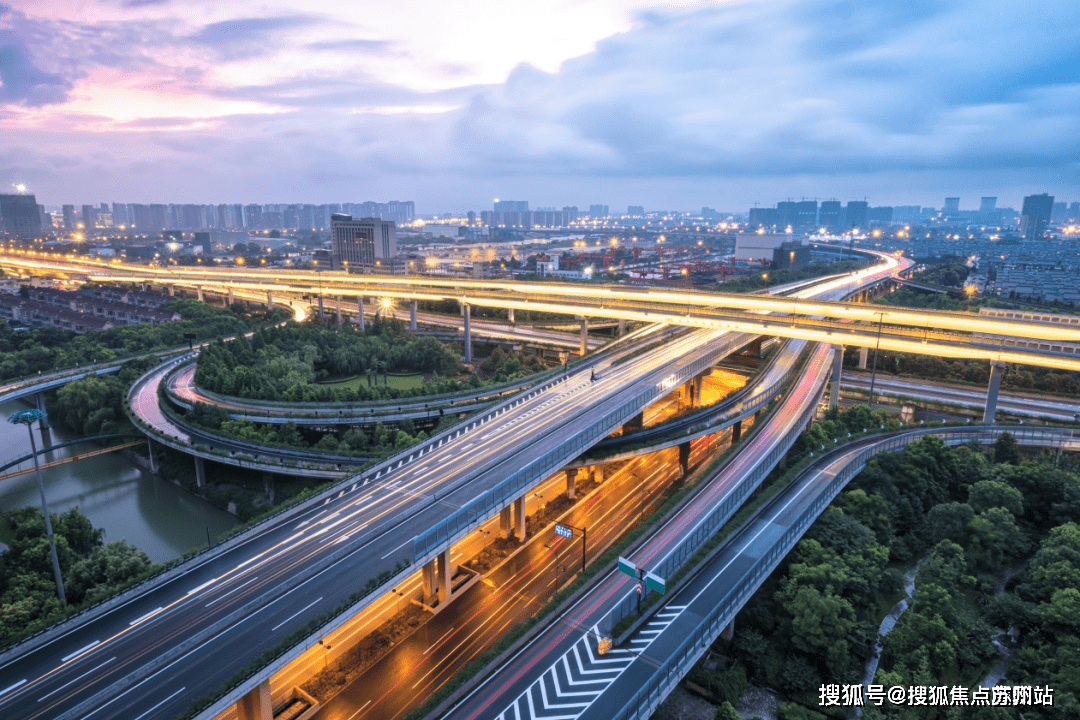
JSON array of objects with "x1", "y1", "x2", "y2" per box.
[{"x1": 413, "y1": 334, "x2": 760, "y2": 562}]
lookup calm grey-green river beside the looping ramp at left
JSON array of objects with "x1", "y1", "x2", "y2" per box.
[{"x1": 0, "y1": 400, "x2": 239, "y2": 562}]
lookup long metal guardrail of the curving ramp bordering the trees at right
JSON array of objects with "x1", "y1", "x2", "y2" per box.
[{"x1": 613, "y1": 426, "x2": 1078, "y2": 720}]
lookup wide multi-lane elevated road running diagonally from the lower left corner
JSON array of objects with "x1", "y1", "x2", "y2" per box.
[{"x1": 0, "y1": 252, "x2": 1062, "y2": 718}]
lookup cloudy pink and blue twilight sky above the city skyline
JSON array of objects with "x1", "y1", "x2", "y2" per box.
[{"x1": 0, "y1": 0, "x2": 1080, "y2": 214}]
